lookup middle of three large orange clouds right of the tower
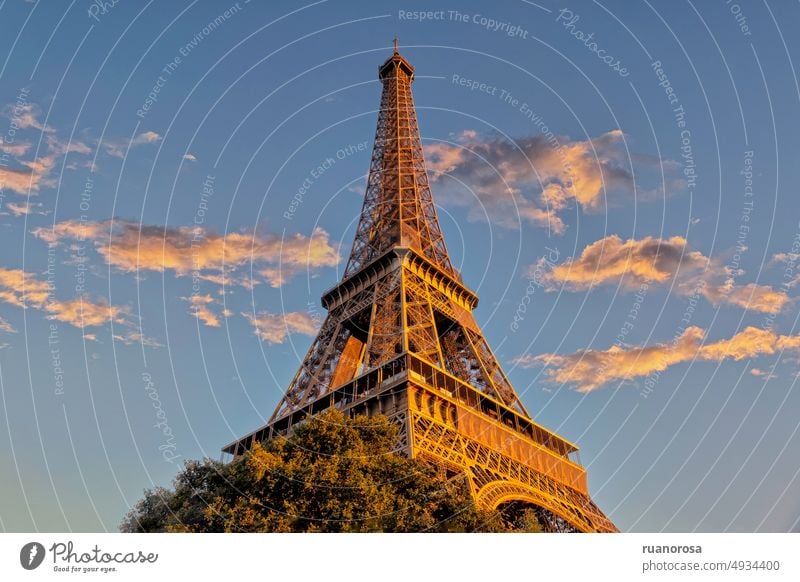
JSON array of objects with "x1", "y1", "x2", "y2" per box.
[{"x1": 530, "y1": 235, "x2": 791, "y2": 313}]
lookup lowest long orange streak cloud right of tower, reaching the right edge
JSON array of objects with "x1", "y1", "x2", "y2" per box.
[{"x1": 514, "y1": 327, "x2": 800, "y2": 392}]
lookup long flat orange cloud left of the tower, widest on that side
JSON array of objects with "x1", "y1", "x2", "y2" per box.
[{"x1": 33, "y1": 220, "x2": 341, "y2": 287}]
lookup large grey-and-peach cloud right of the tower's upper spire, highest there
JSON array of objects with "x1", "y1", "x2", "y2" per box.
[{"x1": 425, "y1": 130, "x2": 682, "y2": 233}]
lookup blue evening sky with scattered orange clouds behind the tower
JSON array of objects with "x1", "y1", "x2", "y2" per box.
[{"x1": 0, "y1": 0, "x2": 800, "y2": 531}]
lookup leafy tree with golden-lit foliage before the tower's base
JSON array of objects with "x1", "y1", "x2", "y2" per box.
[{"x1": 120, "y1": 410, "x2": 541, "y2": 532}]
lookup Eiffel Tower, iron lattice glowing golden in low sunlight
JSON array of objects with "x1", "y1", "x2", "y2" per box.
[{"x1": 223, "y1": 40, "x2": 617, "y2": 532}]
